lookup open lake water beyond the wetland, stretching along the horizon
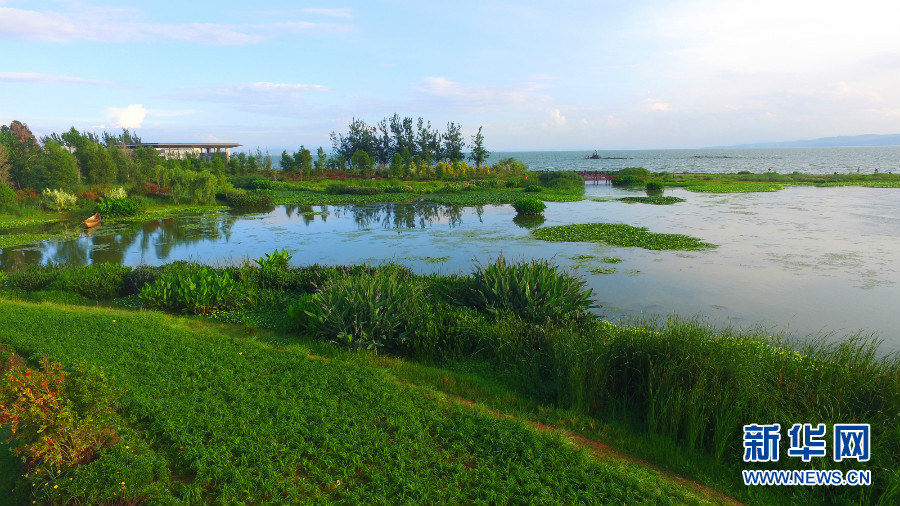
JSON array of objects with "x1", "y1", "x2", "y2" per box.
[{"x1": 490, "y1": 146, "x2": 900, "y2": 174}]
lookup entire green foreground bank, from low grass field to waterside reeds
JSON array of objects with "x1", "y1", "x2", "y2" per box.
[{"x1": 0, "y1": 258, "x2": 900, "y2": 504}]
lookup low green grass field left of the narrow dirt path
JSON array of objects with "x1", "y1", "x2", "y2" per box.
[{"x1": 0, "y1": 301, "x2": 724, "y2": 504}]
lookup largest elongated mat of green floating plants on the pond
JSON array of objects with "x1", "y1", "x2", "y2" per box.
[{"x1": 531, "y1": 223, "x2": 715, "y2": 250}]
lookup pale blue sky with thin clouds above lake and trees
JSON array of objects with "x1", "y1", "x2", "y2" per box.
[{"x1": 0, "y1": 0, "x2": 900, "y2": 153}]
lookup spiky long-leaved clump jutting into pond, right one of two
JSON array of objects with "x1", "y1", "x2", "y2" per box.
[{"x1": 458, "y1": 255, "x2": 594, "y2": 322}]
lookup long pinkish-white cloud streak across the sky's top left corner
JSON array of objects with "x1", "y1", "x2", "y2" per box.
[{"x1": 0, "y1": 7, "x2": 349, "y2": 45}]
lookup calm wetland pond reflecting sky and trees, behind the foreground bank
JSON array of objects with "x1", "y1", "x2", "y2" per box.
[{"x1": 0, "y1": 185, "x2": 900, "y2": 352}]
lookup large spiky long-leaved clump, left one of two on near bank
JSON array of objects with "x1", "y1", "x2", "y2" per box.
[{"x1": 288, "y1": 267, "x2": 425, "y2": 352}]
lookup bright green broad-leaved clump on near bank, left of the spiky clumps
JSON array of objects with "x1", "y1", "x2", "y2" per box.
[{"x1": 140, "y1": 263, "x2": 240, "y2": 314}]
